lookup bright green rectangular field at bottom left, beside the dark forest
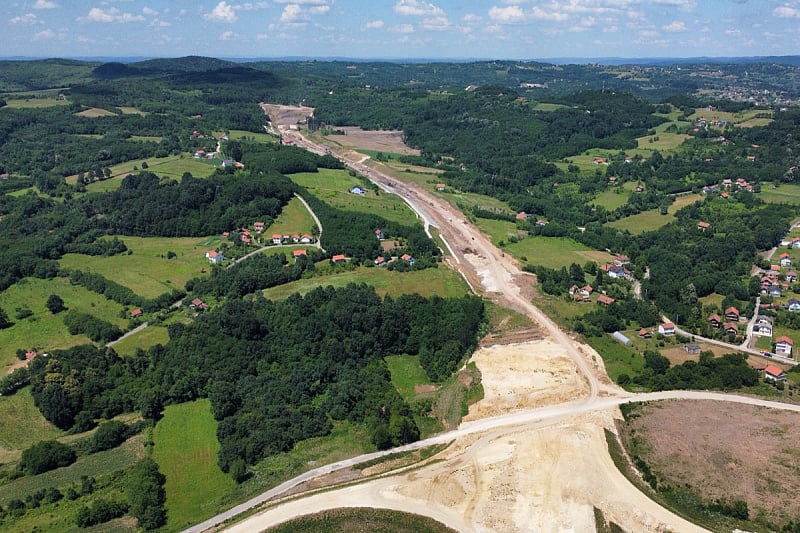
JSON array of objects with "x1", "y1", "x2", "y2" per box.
[{"x1": 153, "y1": 400, "x2": 236, "y2": 531}]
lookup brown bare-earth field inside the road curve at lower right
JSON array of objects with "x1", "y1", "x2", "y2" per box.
[{"x1": 624, "y1": 401, "x2": 800, "y2": 524}]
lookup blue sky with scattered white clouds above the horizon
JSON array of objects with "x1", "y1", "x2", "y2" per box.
[{"x1": 6, "y1": 0, "x2": 800, "y2": 59}]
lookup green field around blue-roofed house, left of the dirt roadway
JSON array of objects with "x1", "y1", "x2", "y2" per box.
[{"x1": 289, "y1": 168, "x2": 417, "y2": 223}]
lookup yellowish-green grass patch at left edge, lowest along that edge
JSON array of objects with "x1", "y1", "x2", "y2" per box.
[{"x1": 0, "y1": 387, "x2": 64, "y2": 463}]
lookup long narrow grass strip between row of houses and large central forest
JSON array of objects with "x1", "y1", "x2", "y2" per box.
[{"x1": 264, "y1": 266, "x2": 469, "y2": 300}]
